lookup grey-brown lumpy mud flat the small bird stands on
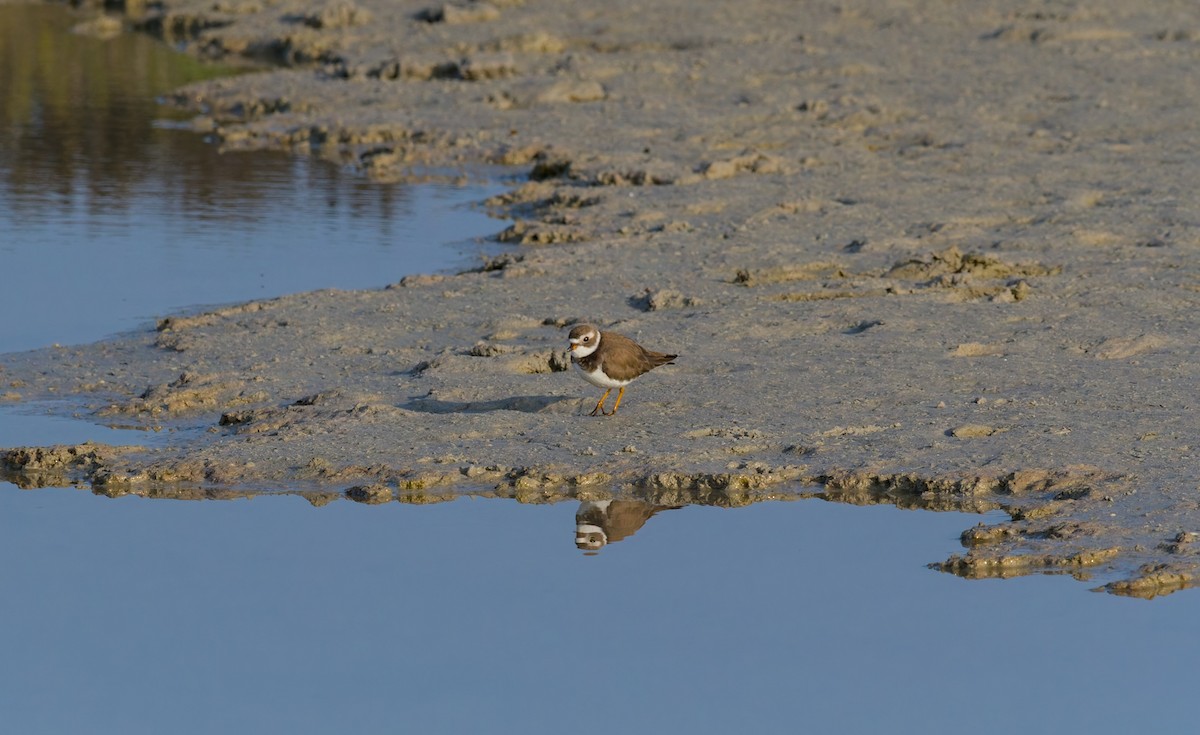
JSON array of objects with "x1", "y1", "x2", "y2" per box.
[{"x1": 0, "y1": 0, "x2": 1200, "y2": 596}]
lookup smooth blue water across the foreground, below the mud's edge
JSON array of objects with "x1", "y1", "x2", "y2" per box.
[{"x1": 0, "y1": 484, "x2": 1200, "y2": 733}]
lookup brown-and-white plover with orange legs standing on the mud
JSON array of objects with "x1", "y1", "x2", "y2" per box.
[{"x1": 570, "y1": 324, "x2": 679, "y2": 416}]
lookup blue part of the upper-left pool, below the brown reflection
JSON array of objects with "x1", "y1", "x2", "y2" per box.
[{"x1": 0, "y1": 175, "x2": 499, "y2": 352}]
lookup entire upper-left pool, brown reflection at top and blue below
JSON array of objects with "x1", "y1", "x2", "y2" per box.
[{"x1": 0, "y1": 5, "x2": 504, "y2": 352}]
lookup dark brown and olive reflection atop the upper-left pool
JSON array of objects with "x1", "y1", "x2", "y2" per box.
[{"x1": 0, "y1": 5, "x2": 427, "y2": 219}]
